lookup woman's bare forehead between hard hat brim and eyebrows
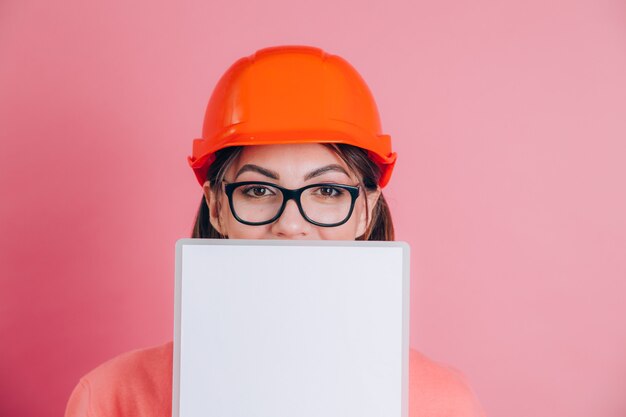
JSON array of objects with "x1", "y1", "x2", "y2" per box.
[{"x1": 231, "y1": 143, "x2": 351, "y2": 177}]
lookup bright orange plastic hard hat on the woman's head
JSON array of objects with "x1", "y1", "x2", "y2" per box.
[{"x1": 188, "y1": 46, "x2": 396, "y2": 187}]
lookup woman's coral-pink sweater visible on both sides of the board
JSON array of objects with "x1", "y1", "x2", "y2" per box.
[{"x1": 65, "y1": 342, "x2": 484, "y2": 417}]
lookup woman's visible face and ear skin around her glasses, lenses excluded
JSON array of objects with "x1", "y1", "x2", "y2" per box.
[{"x1": 203, "y1": 143, "x2": 380, "y2": 240}]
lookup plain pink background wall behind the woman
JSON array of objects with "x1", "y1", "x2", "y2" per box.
[{"x1": 0, "y1": 0, "x2": 626, "y2": 417}]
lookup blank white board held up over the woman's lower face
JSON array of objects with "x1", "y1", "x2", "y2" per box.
[{"x1": 172, "y1": 239, "x2": 409, "y2": 417}]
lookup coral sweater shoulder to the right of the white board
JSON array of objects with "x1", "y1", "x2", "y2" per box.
[{"x1": 409, "y1": 349, "x2": 484, "y2": 417}]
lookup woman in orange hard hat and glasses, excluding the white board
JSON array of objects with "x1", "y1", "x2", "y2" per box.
[{"x1": 66, "y1": 46, "x2": 483, "y2": 417}]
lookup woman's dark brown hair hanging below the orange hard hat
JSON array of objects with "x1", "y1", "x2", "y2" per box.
[{"x1": 191, "y1": 143, "x2": 394, "y2": 240}]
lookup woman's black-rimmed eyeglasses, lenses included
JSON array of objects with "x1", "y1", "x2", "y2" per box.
[{"x1": 224, "y1": 181, "x2": 359, "y2": 227}]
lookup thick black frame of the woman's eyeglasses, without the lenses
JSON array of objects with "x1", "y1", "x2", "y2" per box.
[{"x1": 224, "y1": 181, "x2": 360, "y2": 227}]
